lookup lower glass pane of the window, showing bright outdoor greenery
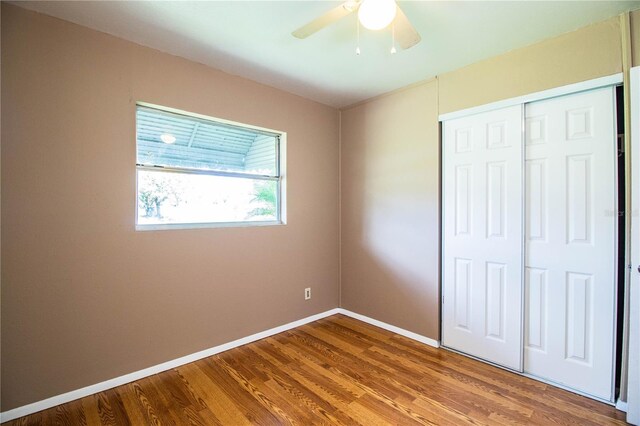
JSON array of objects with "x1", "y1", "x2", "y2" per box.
[{"x1": 138, "y1": 170, "x2": 278, "y2": 225}]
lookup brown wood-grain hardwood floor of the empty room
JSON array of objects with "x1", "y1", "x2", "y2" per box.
[{"x1": 7, "y1": 315, "x2": 625, "y2": 426}]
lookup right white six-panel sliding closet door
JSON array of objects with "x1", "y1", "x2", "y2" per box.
[{"x1": 524, "y1": 88, "x2": 617, "y2": 400}]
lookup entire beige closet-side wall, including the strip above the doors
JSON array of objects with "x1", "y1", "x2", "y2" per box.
[{"x1": 341, "y1": 17, "x2": 622, "y2": 339}]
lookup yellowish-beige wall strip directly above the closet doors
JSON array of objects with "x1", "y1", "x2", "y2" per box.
[{"x1": 439, "y1": 17, "x2": 622, "y2": 114}]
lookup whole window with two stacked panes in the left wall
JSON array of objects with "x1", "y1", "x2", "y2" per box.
[{"x1": 136, "y1": 105, "x2": 284, "y2": 230}]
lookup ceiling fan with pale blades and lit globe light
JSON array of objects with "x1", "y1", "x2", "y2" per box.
[{"x1": 291, "y1": 0, "x2": 421, "y2": 49}]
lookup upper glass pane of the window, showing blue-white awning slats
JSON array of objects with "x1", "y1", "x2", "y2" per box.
[{"x1": 136, "y1": 107, "x2": 278, "y2": 176}]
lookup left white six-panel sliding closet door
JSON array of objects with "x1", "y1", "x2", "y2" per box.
[{"x1": 442, "y1": 105, "x2": 523, "y2": 371}]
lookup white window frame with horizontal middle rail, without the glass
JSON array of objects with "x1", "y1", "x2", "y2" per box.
[{"x1": 135, "y1": 102, "x2": 287, "y2": 231}]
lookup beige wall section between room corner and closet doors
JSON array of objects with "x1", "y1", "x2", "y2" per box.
[{"x1": 341, "y1": 80, "x2": 440, "y2": 338}]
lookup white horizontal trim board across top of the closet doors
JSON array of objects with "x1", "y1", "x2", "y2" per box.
[{"x1": 438, "y1": 73, "x2": 623, "y2": 121}]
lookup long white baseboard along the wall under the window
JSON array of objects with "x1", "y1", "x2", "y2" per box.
[{"x1": 0, "y1": 308, "x2": 340, "y2": 423}]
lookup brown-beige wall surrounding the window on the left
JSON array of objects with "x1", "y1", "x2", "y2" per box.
[{"x1": 1, "y1": 3, "x2": 339, "y2": 411}]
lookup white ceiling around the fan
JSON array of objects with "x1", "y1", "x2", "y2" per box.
[{"x1": 14, "y1": 0, "x2": 640, "y2": 107}]
